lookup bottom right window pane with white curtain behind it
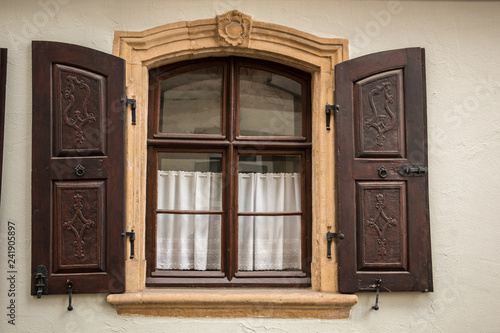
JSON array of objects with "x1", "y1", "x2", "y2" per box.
[{"x1": 238, "y1": 216, "x2": 302, "y2": 271}]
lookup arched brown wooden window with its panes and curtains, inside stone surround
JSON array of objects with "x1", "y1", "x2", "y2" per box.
[{"x1": 146, "y1": 57, "x2": 311, "y2": 286}]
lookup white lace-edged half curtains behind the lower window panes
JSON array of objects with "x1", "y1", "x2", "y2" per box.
[{"x1": 157, "y1": 171, "x2": 301, "y2": 271}]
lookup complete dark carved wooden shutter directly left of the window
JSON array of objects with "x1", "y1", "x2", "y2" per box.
[{"x1": 32, "y1": 41, "x2": 125, "y2": 295}]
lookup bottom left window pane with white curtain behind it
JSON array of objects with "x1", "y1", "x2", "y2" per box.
[{"x1": 156, "y1": 214, "x2": 221, "y2": 271}]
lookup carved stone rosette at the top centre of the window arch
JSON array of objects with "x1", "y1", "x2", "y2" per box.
[{"x1": 217, "y1": 10, "x2": 252, "y2": 46}]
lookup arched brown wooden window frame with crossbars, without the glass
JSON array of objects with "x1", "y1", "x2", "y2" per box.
[{"x1": 146, "y1": 57, "x2": 312, "y2": 287}]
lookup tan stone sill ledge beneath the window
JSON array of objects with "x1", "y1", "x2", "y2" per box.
[{"x1": 107, "y1": 289, "x2": 358, "y2": 319}]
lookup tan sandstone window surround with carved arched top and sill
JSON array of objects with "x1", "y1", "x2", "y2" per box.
[{"x1": 107, "y1": 10, "x2": 357, "y2": 319}]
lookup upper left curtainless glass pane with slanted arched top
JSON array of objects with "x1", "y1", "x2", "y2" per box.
[{"x1": 160, "y1": 67, "x2": 223, "y2": 134}]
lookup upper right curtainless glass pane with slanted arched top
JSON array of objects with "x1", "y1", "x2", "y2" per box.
[{"x1": 240, "y1": 67, "x2": 302, "y2": 136}]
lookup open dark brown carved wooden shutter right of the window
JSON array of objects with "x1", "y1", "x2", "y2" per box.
[{"x1": 335, "y1": 48, "x2": 432, "y2": 293}]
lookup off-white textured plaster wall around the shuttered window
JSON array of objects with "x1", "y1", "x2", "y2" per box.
[{"x1": 0, "y1": 0, "x2": 500, "y2": 333}]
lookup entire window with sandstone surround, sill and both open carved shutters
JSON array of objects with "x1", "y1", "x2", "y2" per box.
[{"x1": 32, "y1": 11, "x2": 432, "y2": 319}]
